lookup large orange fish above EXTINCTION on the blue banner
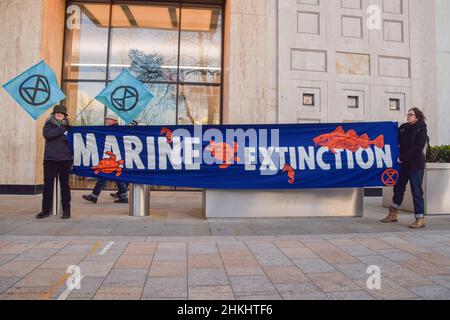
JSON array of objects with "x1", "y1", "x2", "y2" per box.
[{"x1": 314, "y1": 127, "x2": 384, "y2": 154}]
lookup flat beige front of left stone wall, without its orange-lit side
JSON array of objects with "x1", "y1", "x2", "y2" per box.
[{"x1": 0, "y1": 0, "x2": 42, "y2": 185}]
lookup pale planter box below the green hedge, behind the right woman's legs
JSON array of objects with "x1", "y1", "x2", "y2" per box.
[{"x1": 383, "y1": 163, "x2": 450, "y2": 215}]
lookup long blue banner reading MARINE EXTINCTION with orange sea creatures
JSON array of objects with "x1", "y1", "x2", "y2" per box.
[{"x1": 68, "y1": 122, "x2": 399, "y2": 189}]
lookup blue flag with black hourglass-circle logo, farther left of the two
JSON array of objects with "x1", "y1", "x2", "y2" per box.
[{"x1": 3, "y1": 61, "x2": 66, "y2": 120}]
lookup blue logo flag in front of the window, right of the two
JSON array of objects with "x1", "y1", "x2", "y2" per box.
[{"x1": 95, "y1": 70, "x2": 153, "y2": 124}]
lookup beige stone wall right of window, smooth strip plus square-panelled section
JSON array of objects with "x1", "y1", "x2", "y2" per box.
[{"x1": 224, "y1": 0, "x2": 438, "y2": 141}]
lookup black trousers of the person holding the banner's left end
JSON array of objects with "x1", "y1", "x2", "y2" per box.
[{"x1": 42, "y1": 161, "x2": 72, "y2": 213}]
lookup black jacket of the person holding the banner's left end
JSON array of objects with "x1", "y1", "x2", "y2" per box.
[{"x1": 43, "y1": 121, "x2": 72, "y2": 161}]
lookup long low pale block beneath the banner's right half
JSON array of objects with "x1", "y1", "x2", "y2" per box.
[{"x1": 203, "y1": 189, "x2": 364, "y2": 219}]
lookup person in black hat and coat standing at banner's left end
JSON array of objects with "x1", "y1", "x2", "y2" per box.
[{"x1": 36, "y1": 105, "x2": 72, "y2": 219}]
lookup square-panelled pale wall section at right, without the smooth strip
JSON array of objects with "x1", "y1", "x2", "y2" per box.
[{"x1": 278, "y1": 0, "x2": 437, "y2": 140}]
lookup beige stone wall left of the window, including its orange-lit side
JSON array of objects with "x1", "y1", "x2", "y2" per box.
[{"x1": 0, "y1": 0, "x2": 64, "y2": 185}]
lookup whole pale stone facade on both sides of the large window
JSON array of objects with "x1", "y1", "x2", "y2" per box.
[{"x1": 0, "y1": 0, "x2": 450, "y2": 191}]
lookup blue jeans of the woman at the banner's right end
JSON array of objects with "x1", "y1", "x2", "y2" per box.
[{"x1": 393, "y1": 166, "x2": 425, "y2": 219}]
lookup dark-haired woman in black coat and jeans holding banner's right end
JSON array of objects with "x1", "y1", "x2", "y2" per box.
[{"x1": 382, "y1": 108, "x2": 428, "y2": 229}]
